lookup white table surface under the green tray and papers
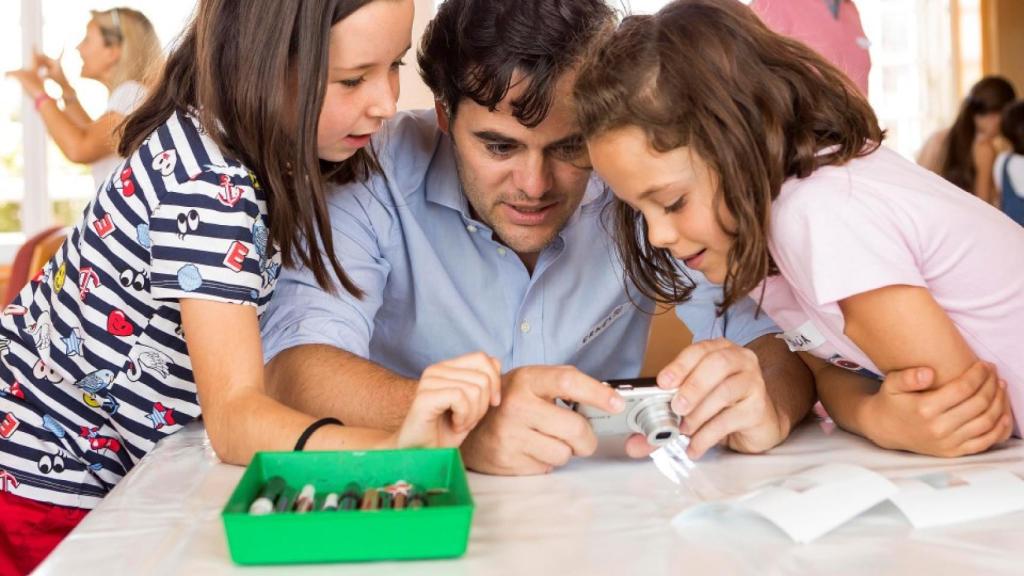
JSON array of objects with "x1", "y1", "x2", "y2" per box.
[{"x1": 37, "y1": 423, "x2": 1024, "y2": 576}]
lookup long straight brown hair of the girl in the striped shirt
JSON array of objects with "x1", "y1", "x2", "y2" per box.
[{"x1": 118, "y1": 0, "x2": 379, "y2": 297}]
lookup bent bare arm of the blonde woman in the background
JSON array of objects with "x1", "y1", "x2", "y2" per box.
[{"x1": 39, "y1": 100, "x2": 124, "y2": 164}]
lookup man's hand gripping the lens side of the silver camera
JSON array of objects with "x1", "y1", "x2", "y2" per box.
[{"x1": 626, "y1": 338, "x2": 791, "y2": 458}]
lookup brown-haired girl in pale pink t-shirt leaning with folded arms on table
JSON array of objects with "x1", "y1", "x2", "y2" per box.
[{"x1": 575, "y1": 0, "x2": 1024, "y2": 456}]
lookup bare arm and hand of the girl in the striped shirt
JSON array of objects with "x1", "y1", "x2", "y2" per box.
[{"x1": 180, "y1": 299, "x2": 501, "y2": 464}]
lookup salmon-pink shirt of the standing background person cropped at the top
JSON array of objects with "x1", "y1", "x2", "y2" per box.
[{"x1": 751, "y1": 0, "x2": 871, "y2": 96}]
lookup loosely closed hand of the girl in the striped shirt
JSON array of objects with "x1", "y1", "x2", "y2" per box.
[{"x1": 394, "y1": 353, "x2": 502, "y2": 448}]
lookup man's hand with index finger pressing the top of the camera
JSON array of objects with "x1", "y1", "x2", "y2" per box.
[{"x1": 462, "y1": 366, "x2": 624, "y2": 476}]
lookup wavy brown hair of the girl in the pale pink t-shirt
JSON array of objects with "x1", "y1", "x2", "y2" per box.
[{"x1": 575, "y1": 0, "x2": 884, "y2": 312}]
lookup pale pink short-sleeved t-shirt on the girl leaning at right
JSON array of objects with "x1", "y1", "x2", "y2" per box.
[{"x1": 752, "y1": 147, "x2": 1024, "y2": 433}]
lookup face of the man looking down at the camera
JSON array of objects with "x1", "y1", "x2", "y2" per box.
[{"x1": 441, "y1": 74, "x2": 590, "y2": 269}]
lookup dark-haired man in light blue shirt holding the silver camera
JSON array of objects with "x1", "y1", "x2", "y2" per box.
[{"x1": 263, "y1": 0, "x2": 995, "y2": 475}]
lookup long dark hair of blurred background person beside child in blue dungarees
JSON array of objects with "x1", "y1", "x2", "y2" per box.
[{"x1": 939, "y1": 76, "x2": 1017, "y2": 194}]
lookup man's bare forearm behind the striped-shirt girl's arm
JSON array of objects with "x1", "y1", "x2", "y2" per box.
[{"x1": 266, "y1": 344, "x2": 417, "y2": 429}]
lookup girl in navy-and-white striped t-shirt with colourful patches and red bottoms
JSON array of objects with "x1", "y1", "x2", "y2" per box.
[{"x1": 0, "y1": 0, "x2": 500, "y2": 574}]
